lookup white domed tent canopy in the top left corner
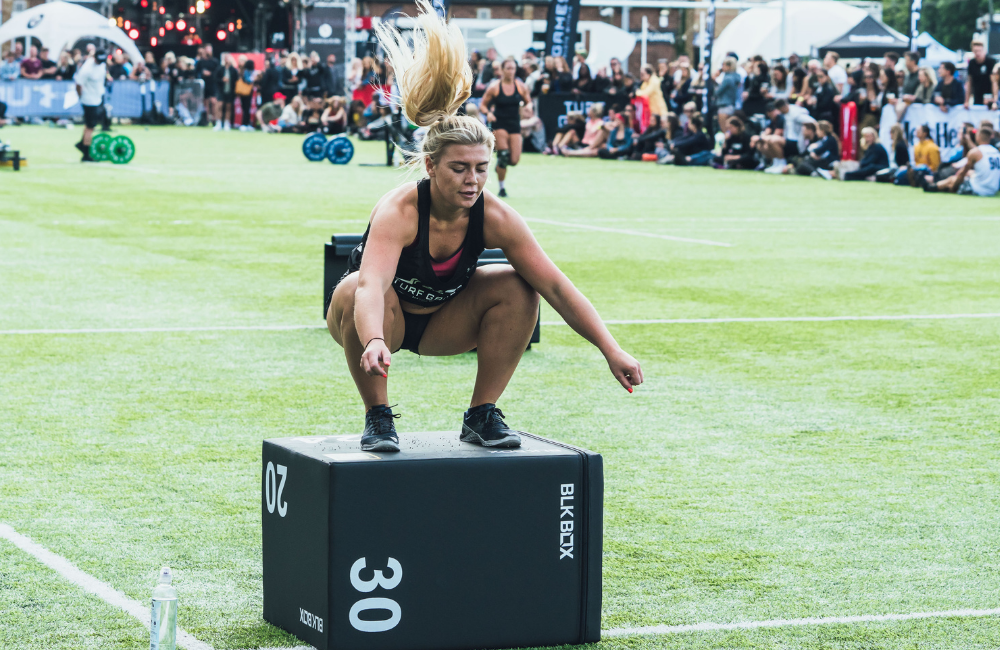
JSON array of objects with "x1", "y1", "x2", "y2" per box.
[{"x1": 0, "y1": 2, "x2": 142, "y2": 61}]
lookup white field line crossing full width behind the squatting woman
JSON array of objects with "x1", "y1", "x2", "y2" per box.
[{"x1": 0, "y1": 313, "x2": 1000, "y2": 336}]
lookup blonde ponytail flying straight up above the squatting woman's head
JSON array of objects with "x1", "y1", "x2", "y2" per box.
[{"x1": 375, "y1": 0, "x2": 472, "y2": 126}]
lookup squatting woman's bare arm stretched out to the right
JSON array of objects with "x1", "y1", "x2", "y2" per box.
[{"x1": 484, "y1": 194, "x2": 642, "y2": 393}]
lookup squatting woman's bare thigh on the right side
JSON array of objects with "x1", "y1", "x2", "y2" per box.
[{"x1": 419, "y1": 264, "x2": 537, "y2": 357}]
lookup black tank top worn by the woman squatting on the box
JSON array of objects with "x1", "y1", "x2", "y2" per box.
[{"x1": 345, "y1": 178, "x2": 486, "y2": 307}]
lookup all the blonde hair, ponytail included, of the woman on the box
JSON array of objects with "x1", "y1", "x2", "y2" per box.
[{"x1": 375, "y1": 0, "x2": 494, "y2": 168}]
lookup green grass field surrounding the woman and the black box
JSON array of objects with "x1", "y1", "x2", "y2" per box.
[{"x1": 0, "y1": 127, "x2": 1000, "y2": 650}]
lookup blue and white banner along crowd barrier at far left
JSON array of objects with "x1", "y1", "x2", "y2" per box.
[{"x1": 0, "y1": 79, "x2": 170, "y2": 118}]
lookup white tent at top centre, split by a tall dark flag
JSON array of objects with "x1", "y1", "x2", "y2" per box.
[{"x1": 486, "y1": 20, "x2": 635, "y2": 73}]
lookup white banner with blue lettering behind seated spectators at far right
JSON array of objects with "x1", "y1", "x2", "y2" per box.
[{"x1": 878, "y1": 104, "x2": 1000, "y2": 161}]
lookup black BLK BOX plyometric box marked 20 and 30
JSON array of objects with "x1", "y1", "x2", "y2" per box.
[{"x1": 261, "y1": 431, "x2": 604, "y2": 650}]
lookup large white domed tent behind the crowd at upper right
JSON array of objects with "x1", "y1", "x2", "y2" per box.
[{"x1": 712, "y1": 0, "x2": 868, "y2": 70}]
